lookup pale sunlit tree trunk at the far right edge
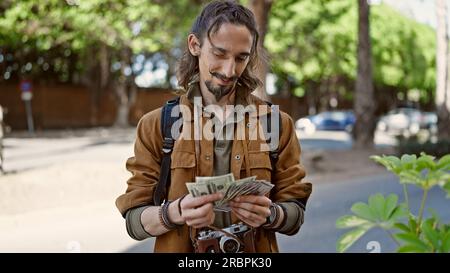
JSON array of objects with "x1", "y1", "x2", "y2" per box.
[{"x1": 435, "y1": 0, "x2": 450, "y2": 139}]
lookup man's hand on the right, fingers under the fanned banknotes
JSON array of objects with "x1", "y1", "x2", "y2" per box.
[{"x1": 230, "y1": 195, "x2": 272, "y2": 227}]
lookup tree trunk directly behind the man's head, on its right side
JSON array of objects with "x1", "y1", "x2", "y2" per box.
[{"x1": 249, "y1": 0, "x2": 272, "y2": 100}]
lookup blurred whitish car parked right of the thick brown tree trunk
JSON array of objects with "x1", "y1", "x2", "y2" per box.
[{"x1": 377, "y1": 108, "x2": 437, "y2": 136}]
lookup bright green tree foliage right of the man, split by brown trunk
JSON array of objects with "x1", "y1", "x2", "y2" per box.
[{"x1": 265, "y1": 0, "x2": 436, "y2": 114}]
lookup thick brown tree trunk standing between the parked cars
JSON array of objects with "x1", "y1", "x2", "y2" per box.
[{"x1": 354, "y1": 0, "x2": 375, "y2": 148}]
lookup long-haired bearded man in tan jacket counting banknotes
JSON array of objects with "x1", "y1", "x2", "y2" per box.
[{"x1": 116, "y1": 1, "x2": 312, "y2": 252}]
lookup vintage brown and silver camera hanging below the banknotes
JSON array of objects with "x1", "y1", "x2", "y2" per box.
[{"x1": 194, "y1": 208, "x2": 255, "y2": 253}]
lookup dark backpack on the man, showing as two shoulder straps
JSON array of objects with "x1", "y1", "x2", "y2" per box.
[{"x1": 153, "y1": 97, "x2": 281, "y2": 206}]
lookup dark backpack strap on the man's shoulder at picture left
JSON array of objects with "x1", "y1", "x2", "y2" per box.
[{"x1": 153, "y1": 97, "x2": 181, "y2": 206}]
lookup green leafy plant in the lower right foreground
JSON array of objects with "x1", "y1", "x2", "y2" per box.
[{"x1": 336, "y1": 153, "x2": 450, "y2": 253}]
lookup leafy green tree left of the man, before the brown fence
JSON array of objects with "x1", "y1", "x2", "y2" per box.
[{"x1": 0, "y1": 0, "x2": 203, "y2": 126}]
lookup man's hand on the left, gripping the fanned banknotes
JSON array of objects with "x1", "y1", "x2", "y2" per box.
[{"x1": 180, "y1": 193, "x2": 223, "y2": 228}]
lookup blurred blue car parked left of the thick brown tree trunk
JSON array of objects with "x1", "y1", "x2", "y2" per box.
[{"x1": 295, "y1": 110, "x2": 355, "y2": 134}]
